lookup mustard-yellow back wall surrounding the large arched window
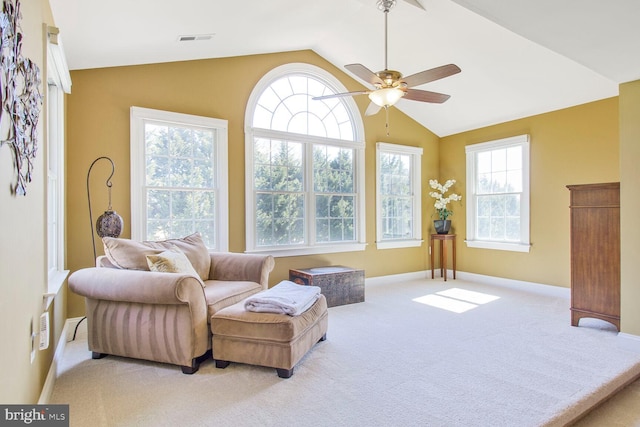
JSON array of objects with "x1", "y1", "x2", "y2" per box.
[{"x1": 67, "y1": 51, "x2": 438, "y2": 316}]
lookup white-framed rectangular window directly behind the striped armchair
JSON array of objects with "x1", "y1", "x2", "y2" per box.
[{"x1": 131, "y1": 107, "x2": 229, "y2": 252}]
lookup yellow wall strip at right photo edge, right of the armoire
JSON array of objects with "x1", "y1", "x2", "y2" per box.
[{"x1": 620, "y1": 80, "x2": 640, "y2": 336}]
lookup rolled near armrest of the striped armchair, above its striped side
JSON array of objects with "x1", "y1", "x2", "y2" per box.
[{"x1": 69, "y1": 267, "x2": 205, "y2": 304}]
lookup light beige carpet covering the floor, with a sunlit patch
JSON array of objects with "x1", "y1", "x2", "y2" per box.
[{"x1": 51, "y1": 279, "x2": 640, "y2": 427}]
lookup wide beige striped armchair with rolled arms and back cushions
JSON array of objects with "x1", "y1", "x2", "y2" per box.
[{"x1": 69, "y1": 234, "x2": 274, "y2": 374}]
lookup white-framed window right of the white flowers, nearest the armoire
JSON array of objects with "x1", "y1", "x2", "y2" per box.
[{"x1": 466, "y1": 135, "x2": 531, "y2": 252}]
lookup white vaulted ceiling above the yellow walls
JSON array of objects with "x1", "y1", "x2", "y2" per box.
[{"x1": 50, "y1": 0, "x2": 640, "y2": 136}]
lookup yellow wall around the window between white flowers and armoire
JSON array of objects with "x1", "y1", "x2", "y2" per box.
[{"x1": 440, "y1": 98, "x2": 620, "y2": 287}]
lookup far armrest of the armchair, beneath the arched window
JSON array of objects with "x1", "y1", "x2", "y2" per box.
[{"x1": 209, "y1": 252, "x2": 275, "y2": 289}]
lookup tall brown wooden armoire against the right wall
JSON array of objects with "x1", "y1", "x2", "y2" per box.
[{"x1": 567, "y1": 182, "x2": 620, "y2": 331}]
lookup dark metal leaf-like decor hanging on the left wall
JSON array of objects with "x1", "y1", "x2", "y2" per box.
[{"x1": 0, "y1": 0, "x2": 42, "y2": 196}]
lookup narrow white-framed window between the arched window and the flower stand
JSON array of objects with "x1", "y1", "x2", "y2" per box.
[{"x1": 376, "y1": 142, "x2": 422, "y2": 249}]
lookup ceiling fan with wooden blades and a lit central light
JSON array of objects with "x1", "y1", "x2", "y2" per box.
[{"x1": 313, "y1": 0, "x2": 460, "y2": 116}]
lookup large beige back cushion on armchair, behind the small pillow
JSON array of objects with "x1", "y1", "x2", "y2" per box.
[{"x1": 102, "y1": 233, "x2": 211, "y2": 280}]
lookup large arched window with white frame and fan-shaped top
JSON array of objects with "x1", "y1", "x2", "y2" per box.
[{"x1": 245, "y1": 64, "x2": 365, "y2": 256}]
